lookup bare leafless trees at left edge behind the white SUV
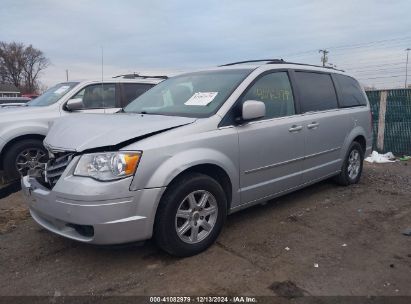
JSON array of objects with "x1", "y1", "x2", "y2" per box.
[{"x1": 0, "y1": 42, "x2": 50, "y2": 92}]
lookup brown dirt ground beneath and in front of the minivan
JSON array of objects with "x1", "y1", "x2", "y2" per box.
[{"x1": 0, "y1": 162, "x2": 411, "y2": 297}]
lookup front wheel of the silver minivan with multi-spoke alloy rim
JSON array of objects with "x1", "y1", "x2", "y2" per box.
[{"x1": 154, "y1": 173, "x2": 227, "y2": 257}]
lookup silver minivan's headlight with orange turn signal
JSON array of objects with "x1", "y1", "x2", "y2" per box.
[{"x1": 74, "y1": 151, "x2": 142, "y2": 181}]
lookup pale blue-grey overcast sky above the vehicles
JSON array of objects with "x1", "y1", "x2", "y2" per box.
[{"x1": 0, "y1": 0, "x2": 411, "y2": 85}]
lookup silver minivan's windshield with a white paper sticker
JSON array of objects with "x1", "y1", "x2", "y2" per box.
[{"x1": 124, "y1": 69, "x2": 252, "y2": 118}]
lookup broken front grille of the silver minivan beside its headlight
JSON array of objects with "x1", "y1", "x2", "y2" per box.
[{"x1": 43, "y1": 152, "x2": 74, "y2": 189}]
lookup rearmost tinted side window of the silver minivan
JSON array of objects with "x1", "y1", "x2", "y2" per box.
[{"x1": 333, "y1": 74, "x2": 367, "y2": 108}]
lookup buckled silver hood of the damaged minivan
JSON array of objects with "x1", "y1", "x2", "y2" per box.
[{"x1": 44, "y1": 113, "x2": 196, "y2": 152}]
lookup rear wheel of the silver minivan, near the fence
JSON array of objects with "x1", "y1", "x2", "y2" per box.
[{"x1": 335, "y1": 141, "x2": 364, "y2": 186}]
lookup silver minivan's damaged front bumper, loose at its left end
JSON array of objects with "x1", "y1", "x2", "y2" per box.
[{"x1": 21, "y1": 171, "x2": 165, "y2": 244}]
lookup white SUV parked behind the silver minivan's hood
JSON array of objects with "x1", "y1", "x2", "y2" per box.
[{"x1": 0, "y1": 75, "x2": 166, "y2": 180}]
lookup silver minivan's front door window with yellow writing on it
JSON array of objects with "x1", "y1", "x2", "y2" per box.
[{"x1": 242, "y1": 72, "x2": 295, "y2": 119}]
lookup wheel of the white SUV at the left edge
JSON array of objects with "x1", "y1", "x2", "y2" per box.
[{"x1": 3, "y1": 139, "x2": 48, "y2": 180}]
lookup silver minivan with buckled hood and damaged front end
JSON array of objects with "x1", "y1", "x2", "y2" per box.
[{"x1": 22, "y1": 60, "x2": 372, "y2": 256}]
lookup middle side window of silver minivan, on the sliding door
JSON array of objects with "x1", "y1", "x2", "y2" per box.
[{"x1": 295, "y1": 72, "x2": 338, "y2": 113}]
